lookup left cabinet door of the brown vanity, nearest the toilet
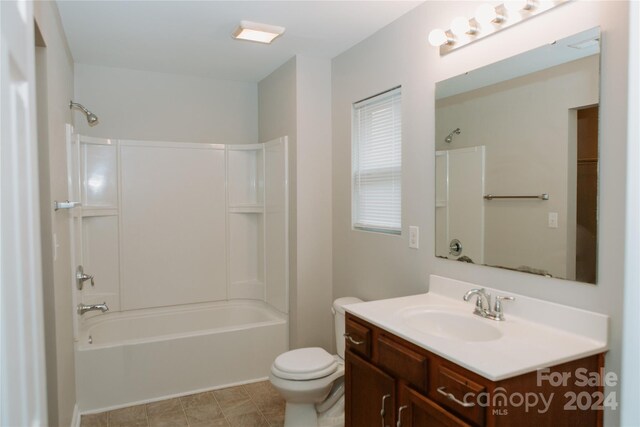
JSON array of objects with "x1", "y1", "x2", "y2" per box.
[{"x1": 345, "y1": 351, "x2": 396, "y2": 427}]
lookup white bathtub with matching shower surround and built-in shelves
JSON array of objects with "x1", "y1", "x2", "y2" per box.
[{"x1": 68, "y1": 125, "x2": 288, "y2": 413}]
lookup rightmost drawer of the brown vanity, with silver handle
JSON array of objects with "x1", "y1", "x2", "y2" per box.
[{"x1": 431, "y1": 366, "x2": 486, "y2": 426}]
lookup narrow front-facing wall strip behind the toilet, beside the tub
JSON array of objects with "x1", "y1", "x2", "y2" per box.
[{"x1": 295, "y1": 56, "x2": 334, "y2": 350}]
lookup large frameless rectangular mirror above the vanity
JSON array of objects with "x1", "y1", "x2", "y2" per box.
[{"x1": 435, "y1": 28, "x2": 600, "y2": 283}]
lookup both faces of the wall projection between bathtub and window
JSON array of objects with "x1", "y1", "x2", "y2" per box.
[{"x1": 259, "y1": 56, "x2": 334, "y2": 349}]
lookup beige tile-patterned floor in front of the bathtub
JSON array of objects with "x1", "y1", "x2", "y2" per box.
[{"x1": 80, "y1": 381, "x2": 285, "y2": 427}]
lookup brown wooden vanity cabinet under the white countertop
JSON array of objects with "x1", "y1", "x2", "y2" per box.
[{"x1": 345, "y1": 313, "x2": 604, "y2": 427}]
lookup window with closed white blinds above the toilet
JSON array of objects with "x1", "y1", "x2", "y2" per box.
[{"x1": 351, "y1": 87, "x2": 402, "y2": 234}]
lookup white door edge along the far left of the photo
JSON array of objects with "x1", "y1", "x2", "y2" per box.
[{"x1": 0, "y1": 0, "x2": 48, "y2": 426}]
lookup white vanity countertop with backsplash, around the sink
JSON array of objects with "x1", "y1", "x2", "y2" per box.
[{"x1": 345, "y1": 276, "x2": 609, "y2": 381}]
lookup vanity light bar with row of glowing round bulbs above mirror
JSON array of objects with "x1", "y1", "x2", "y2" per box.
[{"x1": 429, "y1": 0, "x2": 572, "y2": 55}]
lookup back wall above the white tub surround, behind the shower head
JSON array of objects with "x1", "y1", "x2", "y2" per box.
[{"x1": 74, "y1": 64, "x2": 258, "y2": 144}]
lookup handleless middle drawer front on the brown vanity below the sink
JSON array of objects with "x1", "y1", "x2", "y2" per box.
[{"x1": 378, "y1": 335, "x2": 428, "y2": 391}]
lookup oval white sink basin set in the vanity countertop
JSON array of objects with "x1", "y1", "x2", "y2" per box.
[{"x1": 402, "y1": 310, "x2": 502, "y2": 341}]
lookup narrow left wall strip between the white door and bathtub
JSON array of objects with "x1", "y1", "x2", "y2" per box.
[{"x1": 34, "y1": 2, "x2": 76, "y2": 426}]
